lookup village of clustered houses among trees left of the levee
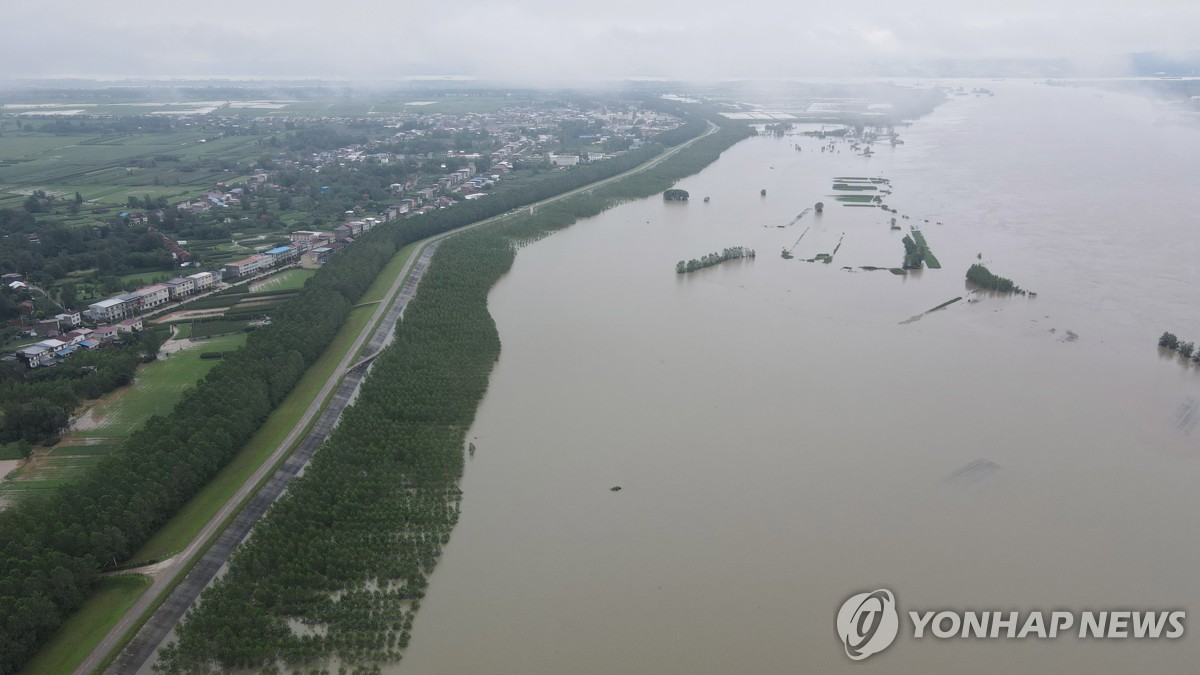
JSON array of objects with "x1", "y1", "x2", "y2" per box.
[{"x1": 2, "y1": 104, "x2": 679, "y2": 369}]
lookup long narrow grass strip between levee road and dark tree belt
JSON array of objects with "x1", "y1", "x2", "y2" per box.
[{"x1": 128, "y1": 241, "x2": 414, "y2": 563}]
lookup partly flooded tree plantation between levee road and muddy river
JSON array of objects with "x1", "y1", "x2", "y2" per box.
[{"x1": 158, "y1": 114, "x2": 750, "y2": 673}]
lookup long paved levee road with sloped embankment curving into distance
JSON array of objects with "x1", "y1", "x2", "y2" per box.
[{"x1": 84, "y1": 123, "x2": 719, "y2": 675}]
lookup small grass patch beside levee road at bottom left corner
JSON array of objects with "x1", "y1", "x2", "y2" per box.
[{"x1": 22, "y1": 574, "x2": 150, "y2": 675}]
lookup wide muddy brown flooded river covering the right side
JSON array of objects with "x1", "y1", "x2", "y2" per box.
[{"x1": 395, "y1": 82, "x2": 1200, "y2": 674}]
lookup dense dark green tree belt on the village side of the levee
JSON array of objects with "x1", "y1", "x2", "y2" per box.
[{"x1": 0, "y1": 110, "x2": 729, "y2": 675}]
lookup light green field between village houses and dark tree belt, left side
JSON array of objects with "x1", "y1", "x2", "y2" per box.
[{"x1": 72, "y1": 335, "x2": 246, "y2": 438}]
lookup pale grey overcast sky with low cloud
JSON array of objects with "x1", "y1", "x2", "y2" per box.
[{"x1": 0, "y1": 0, "x2": 1200, "y2": 84}]
